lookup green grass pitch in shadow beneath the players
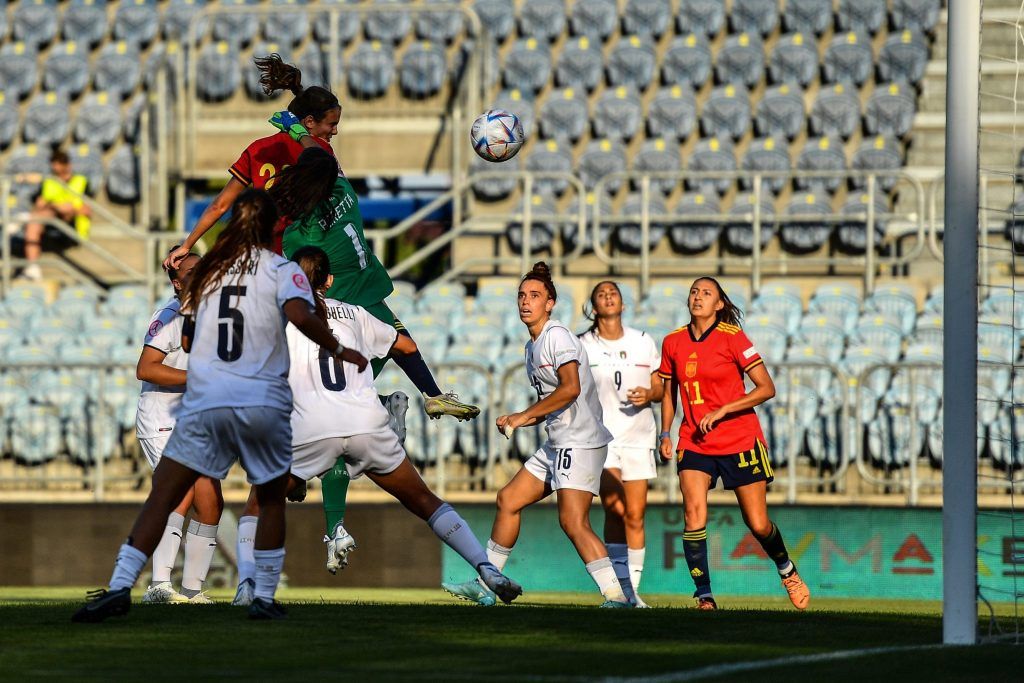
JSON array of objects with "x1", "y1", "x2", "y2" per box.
[{"x1": 0, "y1": 588, "x2": 1024, "y2": 683}]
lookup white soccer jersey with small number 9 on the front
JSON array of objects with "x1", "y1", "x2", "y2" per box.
[{"x1": 580, "y1": 327, "x2": 662, "y2": 449}]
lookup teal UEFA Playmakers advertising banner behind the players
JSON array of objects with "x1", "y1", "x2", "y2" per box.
[{"x1": 441, "y1": 505, "x2": 1024, "y2": 601}]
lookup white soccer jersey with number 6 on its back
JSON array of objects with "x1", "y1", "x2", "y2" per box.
[{"x1": 288, "y1": 299, "x2": 398, "y2": 445}]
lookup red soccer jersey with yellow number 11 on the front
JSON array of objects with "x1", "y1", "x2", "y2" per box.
[{"x1": 657, "y1": 323, "x2": 764, "y2": 456}]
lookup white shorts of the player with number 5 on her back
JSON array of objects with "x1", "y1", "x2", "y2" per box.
[{"x1": 164, "y1": 407, "x2": 292, "y2": 484}]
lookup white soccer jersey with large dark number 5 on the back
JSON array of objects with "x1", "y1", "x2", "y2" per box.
[{"x1": 180, "y1": 249, "x2": 313, "y2": 416}]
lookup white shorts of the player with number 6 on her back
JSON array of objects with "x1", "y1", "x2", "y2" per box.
[{"x1": 292, "y1": 429, "x2": 406, "y2": 480}]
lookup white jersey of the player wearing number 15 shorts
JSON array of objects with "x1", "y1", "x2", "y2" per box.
[{"x1": 526, "y1": 321, "x2": 611, "y2": 449}]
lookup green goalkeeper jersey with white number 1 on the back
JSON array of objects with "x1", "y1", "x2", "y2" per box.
[{"x1": 282, "y1": 176, "x2": 394, "y2": 307}]
